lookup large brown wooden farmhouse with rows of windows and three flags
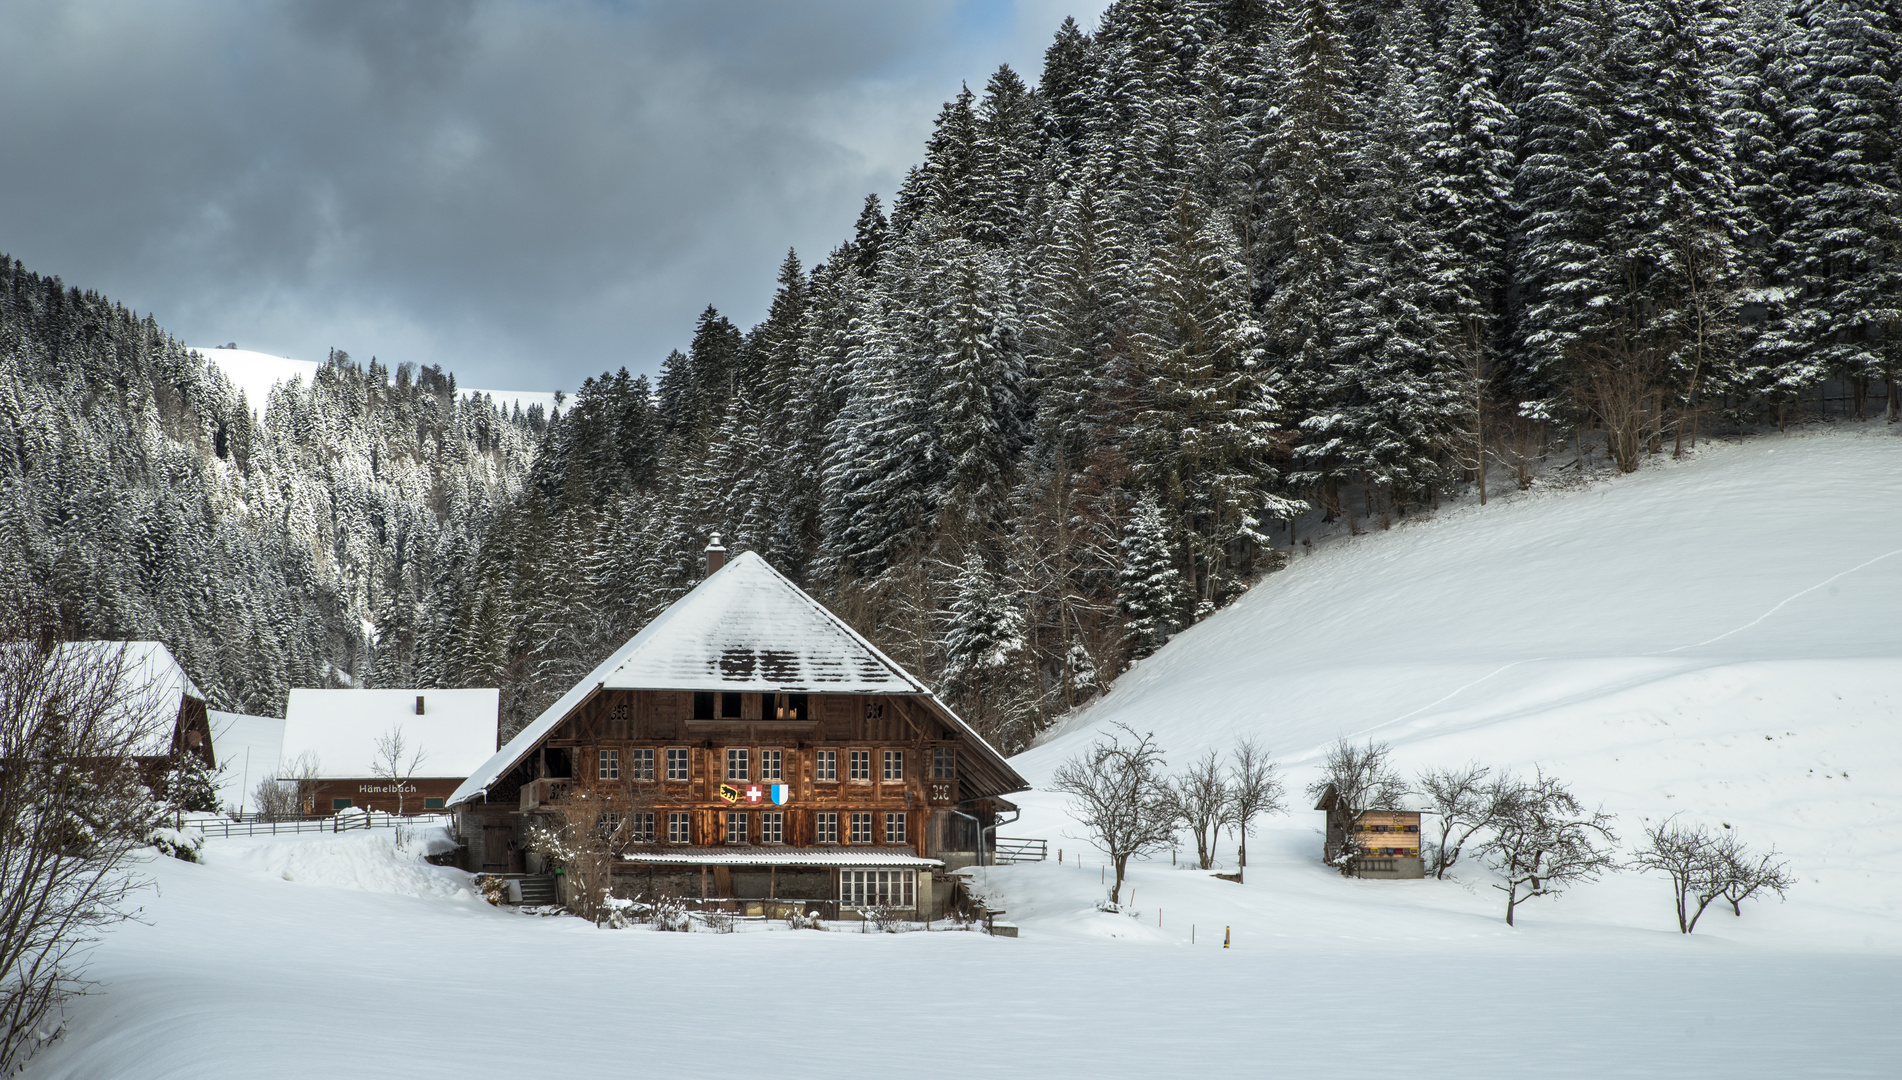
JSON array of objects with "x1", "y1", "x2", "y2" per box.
[{"x1": 449, "y1": 536, "x2": 1029, "y2": 918}]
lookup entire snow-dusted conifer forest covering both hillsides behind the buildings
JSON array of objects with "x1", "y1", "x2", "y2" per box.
[{"x1": 0, "y1": 0, "x2": 1902, "y2": 753}]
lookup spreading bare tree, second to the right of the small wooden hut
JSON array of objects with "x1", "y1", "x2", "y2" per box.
[{"x1": 1482, "y1": 772, "x2": 1619, "y2": 926}]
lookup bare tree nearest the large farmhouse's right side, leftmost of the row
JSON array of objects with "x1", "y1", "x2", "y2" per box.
[{"x1": 1050, "y1": 724, "x2": 1175, "y2": 903}]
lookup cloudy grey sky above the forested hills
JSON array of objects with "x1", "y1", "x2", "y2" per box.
[{"x1": 0, "y1": 0, "x2": 1105, "y2": 390}]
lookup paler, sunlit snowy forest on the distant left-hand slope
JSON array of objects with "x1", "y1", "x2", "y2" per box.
[{"x1": 0, "y1": 259, "x2": 546, "y2": 715}]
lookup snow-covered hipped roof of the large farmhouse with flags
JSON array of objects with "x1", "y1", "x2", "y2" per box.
[{"x1": 449, "y1": 551, "x2": 1021, "y2": 806}]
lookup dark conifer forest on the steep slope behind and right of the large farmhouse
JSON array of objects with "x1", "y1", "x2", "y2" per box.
[{"x1": 427, "y1": 0, "x2": 1902, "y2": 749}]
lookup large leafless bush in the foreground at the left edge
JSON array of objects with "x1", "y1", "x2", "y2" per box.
[{"x1": 0, "y1": 631, "x2": 169, "y2": 1074}]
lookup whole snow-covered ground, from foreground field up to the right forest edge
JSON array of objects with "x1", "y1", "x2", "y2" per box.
[{"x1": 18, "y1": 426, "x2": 1902, "y2": 1078}]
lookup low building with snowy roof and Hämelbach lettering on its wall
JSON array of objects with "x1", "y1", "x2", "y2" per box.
[{"x1": 278, "y1": 688, "x2": 500, "y2": 814}]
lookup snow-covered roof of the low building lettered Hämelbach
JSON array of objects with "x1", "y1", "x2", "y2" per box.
[{"x1": 280, "y1": 688, "x2": 500, "y2": 778}]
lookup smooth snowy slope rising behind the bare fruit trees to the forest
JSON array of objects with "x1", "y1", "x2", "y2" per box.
[{"x1": 1010, "y1": 426, "x2": 1902, "y2": 939}]
